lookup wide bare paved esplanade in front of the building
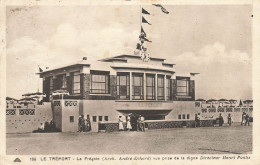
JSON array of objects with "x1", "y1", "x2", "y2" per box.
[{"x1": 7, "y1": 126, "x2": 252, "y2": 155}]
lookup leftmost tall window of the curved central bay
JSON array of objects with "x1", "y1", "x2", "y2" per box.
[{"x1": 117, "y1": 73, "x2": 130, "y2": 100}]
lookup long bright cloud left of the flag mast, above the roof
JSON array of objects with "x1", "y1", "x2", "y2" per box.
[{"x1": 7, "y1": 23, "x2": 138, "y2": 98}]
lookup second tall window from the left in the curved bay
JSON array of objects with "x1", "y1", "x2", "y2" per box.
[{"x1": 132, "y1": 73, "x2": 144, "y2": 100}]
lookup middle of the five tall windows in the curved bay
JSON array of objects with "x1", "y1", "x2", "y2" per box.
[{"x1": 146, "y1": 74, "x2": 155, "y2": 100}]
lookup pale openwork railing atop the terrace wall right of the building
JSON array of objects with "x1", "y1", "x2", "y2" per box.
[{"x1": 201, "y1": 107, "x2": 253, "y2": 113}]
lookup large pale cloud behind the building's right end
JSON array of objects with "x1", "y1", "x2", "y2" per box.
[{"x1": 171, "y1": 42, "x2": 252, "y2": 99}]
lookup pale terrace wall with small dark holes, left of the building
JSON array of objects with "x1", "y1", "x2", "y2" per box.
[{"x1": 6, "y1": 102, "x2": 52, "y2": 133}]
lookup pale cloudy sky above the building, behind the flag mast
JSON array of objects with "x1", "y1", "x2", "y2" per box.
[{"x1": 6, "y1": 5, "x2": 252, "y2": 99}]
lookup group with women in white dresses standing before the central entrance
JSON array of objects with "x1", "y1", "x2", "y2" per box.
[{"x1": 118, "y1": 115, "x2": 145, "y2": 132}]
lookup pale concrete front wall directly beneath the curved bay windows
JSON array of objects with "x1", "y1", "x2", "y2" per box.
[{"x1": 80, "y1": 100, "x2": 200, "y2": 122}]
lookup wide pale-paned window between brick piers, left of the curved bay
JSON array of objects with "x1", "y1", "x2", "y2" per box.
[{"x1": 90, "y1": 71, "x2": 110, "y2": 94}]
